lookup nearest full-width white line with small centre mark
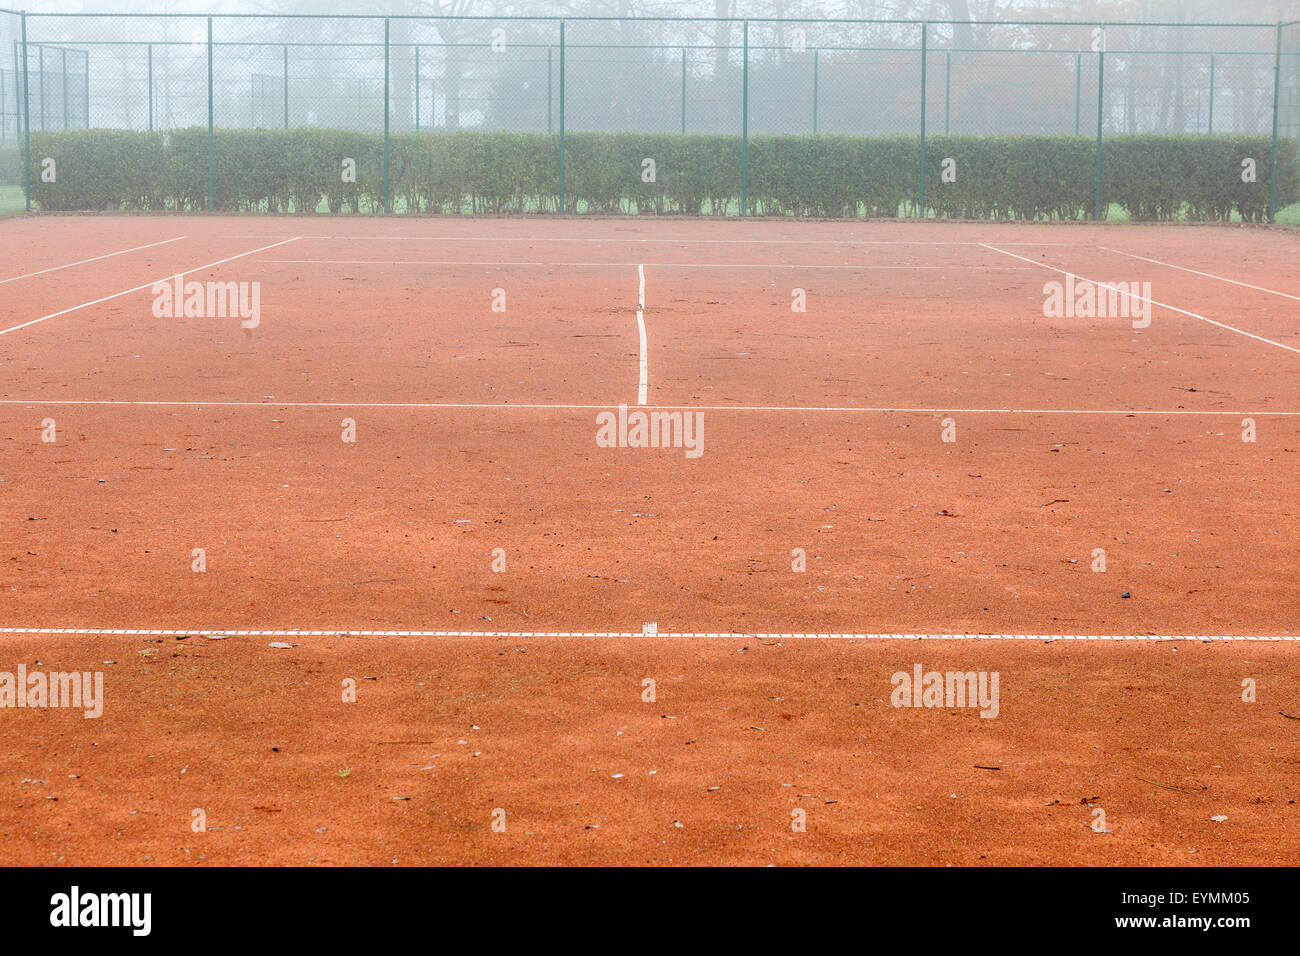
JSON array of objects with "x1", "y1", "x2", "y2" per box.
[{"x1": 0, "y1": 627, "x2": 1300, "y2": 643}]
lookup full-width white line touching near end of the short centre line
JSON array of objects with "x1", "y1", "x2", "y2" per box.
[{"x1": 0, "y1": 398, "x2": 1300, "y2": 418}]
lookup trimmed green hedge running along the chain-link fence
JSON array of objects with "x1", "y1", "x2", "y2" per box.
[{"x1": 22, "y1": 127, "x2": 1300, "y2": 221}]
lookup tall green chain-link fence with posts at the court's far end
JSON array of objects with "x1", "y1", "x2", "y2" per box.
[{"x1": 0, "y1": 12, "x2": 1300, "y2": 219}]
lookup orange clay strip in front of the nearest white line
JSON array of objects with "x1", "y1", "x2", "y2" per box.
[{"x1": 0, "y1": 637, "x2": 1300, "y2": 865}]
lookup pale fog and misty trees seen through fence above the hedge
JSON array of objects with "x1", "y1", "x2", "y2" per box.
[{"x1": 0, "y1": 0, "x2": 1300, "y2": 144}]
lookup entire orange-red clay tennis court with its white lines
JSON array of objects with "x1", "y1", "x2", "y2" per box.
[{"x1": 0, "y1": 217, "x2": 1300, "y2": 865}]
